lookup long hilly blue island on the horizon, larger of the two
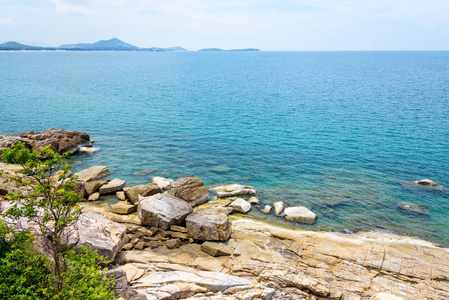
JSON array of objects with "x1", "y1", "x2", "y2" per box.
[{"x1": 0, "y1": 38, "x2": 187, "y2": 52}]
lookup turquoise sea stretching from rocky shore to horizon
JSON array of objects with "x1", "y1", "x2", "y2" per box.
[{"x1": 0, "y1": 52, "x2": 449, "y2": 246}]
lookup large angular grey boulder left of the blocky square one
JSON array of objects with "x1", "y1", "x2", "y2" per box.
[{"x1": 137, "y1": 193, "x2": 192, "y2": 230}]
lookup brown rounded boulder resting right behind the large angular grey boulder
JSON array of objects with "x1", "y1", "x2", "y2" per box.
[{"x1": 168, "y1": 177, "x2": 209, "y2": 207}]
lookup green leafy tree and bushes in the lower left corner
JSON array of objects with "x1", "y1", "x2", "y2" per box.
[{"x1": 0, "y1": 143, "x2": 113, "y2": 299}]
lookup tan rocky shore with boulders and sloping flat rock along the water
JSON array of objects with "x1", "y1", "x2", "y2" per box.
[{"x1": 0, "y1": 129, "x2": 449, "y2": 300}]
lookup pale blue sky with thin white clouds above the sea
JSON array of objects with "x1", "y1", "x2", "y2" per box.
[{"x1": 0, "y1": 0, "x2": 449, "y2": 51}]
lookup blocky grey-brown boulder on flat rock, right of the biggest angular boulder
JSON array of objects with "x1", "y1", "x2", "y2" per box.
[{"x1": 186, "y1": 210, "x2": 232, "y2": 241}]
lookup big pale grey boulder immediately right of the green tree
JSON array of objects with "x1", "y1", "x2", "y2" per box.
[{"x1": 68, "y1": 211, "x2": 126, "y2": 260}]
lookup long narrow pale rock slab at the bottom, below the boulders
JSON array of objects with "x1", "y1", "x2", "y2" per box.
[{"x1": 134, "y1": 271, "x2": 252, "y2": 293}]
